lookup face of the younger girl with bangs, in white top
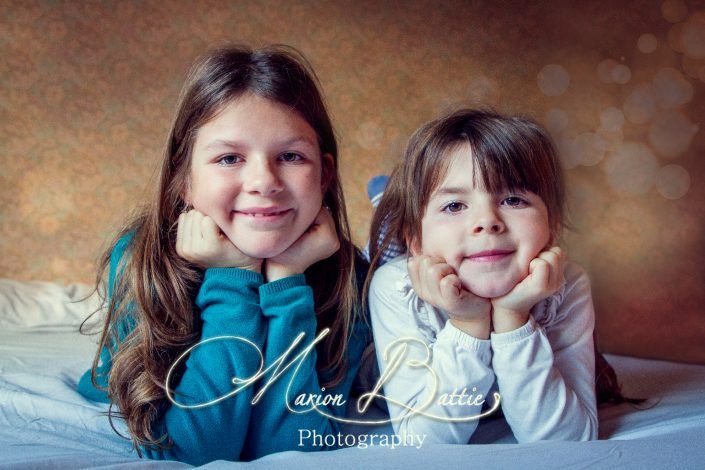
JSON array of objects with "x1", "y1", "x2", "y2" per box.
[{"x1": 420, "y1": 144, "x2": 551, "y2": 298}]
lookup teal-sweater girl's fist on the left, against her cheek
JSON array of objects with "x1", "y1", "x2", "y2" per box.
[{"x1": 176, "y1": 209, "x2": 262, "y2": 272}]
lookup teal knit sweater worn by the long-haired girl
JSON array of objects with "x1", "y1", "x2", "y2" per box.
[{"x1": 78, "y1": 237, "x2": 369, "y2": 465}]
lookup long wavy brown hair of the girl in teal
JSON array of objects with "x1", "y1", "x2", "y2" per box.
[{"x1": 81, "y1": 46, "x2": 359, "y2": 452}]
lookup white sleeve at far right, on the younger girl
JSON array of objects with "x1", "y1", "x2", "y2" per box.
[{"x1": 491, "y1": 266, "x2": 597, "y2": 442}]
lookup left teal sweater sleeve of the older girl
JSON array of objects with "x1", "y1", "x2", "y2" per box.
[{"x1": 143, "y1": 268, "x2": 266, "y2": 465}]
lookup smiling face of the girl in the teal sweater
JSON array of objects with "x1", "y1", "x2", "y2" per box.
[{"x1": 186, "y1": 94, "x2": 333, "y2": 259}]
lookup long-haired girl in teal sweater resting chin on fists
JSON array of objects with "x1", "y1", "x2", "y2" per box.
[{"x1": 78, "y1": 47, "x2": 369, "y2": 464}]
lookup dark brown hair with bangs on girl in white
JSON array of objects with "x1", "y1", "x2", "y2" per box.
[{"x1": 368, "y1": 109, "x2": 565, "y2": 272}]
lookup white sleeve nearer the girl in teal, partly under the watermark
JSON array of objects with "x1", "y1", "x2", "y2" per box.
[{"x1": 369, "y1": 263, "x2": 494, "y2": 444}]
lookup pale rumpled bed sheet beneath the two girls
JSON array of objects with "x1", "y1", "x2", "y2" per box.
[{"x1": 0, "y1": 280, "x2": 705, "y2": 469}]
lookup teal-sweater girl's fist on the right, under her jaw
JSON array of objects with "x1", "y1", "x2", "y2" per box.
[{"x1": 265, "y1": 207, "x2": 340, "y2": 282}]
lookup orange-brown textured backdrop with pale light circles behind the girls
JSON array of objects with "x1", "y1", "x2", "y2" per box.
[{"x1": 0, "y1": 0, "x2": 705, "y2": 362}]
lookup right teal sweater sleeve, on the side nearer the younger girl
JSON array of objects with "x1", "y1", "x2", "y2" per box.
[{"x1": 244, "y1": 274, "x2": 367, "y2": 460}]
